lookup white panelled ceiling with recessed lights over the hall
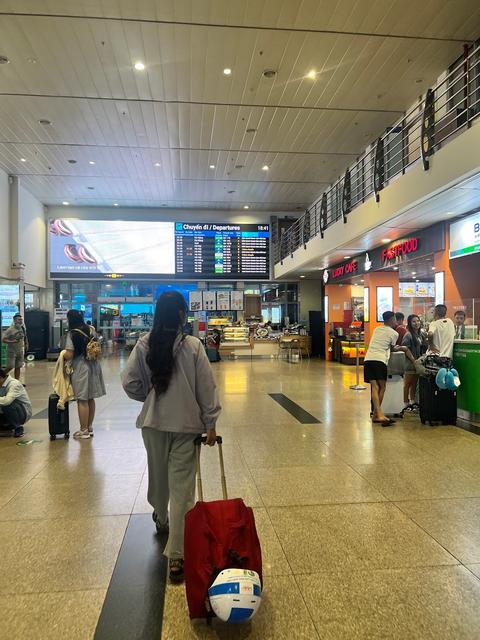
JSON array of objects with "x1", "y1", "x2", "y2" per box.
[{"x1": 0, "y1": 0, "x2": 474, "y2": 210}]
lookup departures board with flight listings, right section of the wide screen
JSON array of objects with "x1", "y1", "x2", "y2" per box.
[{"x1": 175, "y1": 222, "x2": 270, "y2": 278}]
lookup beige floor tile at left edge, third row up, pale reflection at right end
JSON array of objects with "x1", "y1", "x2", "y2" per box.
[{"x1": 0, "y1": 473, "x2": 142, "y2": 521}]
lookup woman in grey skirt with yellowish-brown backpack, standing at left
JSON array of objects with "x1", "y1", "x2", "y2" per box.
[{"x1": 64, "y1": 309, "x2": 106, "y2": 440}]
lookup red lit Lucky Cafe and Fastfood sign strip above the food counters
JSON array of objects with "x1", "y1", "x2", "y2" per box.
[{"x1": 323, "y1": 226, "x2": 445, "y2": 284}]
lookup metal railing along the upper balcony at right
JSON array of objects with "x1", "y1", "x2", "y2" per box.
[{"x1": 273, "y1": 42, "x2": 480, "y2": 264}]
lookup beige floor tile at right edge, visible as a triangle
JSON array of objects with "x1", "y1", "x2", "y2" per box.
[{"x1": 397, "y1": 498, "x2": 480, "y2": 564}]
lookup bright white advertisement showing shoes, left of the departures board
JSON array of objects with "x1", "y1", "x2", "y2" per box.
[{"x1": 49, "y1": 219, "x2": 175, "y2": 278}]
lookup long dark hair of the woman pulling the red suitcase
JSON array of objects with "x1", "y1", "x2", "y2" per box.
[{"x1": 147, "y1": 291, "x2": 187, "y2": 395}]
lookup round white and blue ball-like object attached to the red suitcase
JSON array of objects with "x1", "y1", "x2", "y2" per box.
[{"x1": 208, "y1": 569, "x2": 262, "y2": 622}]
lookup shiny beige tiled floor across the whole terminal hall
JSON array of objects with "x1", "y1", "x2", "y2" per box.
[{"x1": 0, "y1": 357, "x2": 480, "y2": 640}]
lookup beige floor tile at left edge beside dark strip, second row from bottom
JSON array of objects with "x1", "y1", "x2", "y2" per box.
[{"x1": 0, "y1": 516, "x2": 128, "y2": 595}]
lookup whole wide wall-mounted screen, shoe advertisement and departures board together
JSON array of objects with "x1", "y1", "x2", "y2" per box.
[{"x1": 49, "y1": 218, "x2": 270, "y2": 280}]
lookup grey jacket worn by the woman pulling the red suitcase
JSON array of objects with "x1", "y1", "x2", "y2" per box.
[{"x1": 121, "y1": 334, "x2": 221, "y2": 433}]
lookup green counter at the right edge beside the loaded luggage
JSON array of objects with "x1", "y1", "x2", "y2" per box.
[{"x1": 453, "y1": 340, "x2": 480, "y2": 421}]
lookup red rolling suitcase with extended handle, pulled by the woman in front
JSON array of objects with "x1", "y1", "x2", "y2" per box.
[{"x1": 184, "y1": 436, "x2": 262, "y2": 618}]
